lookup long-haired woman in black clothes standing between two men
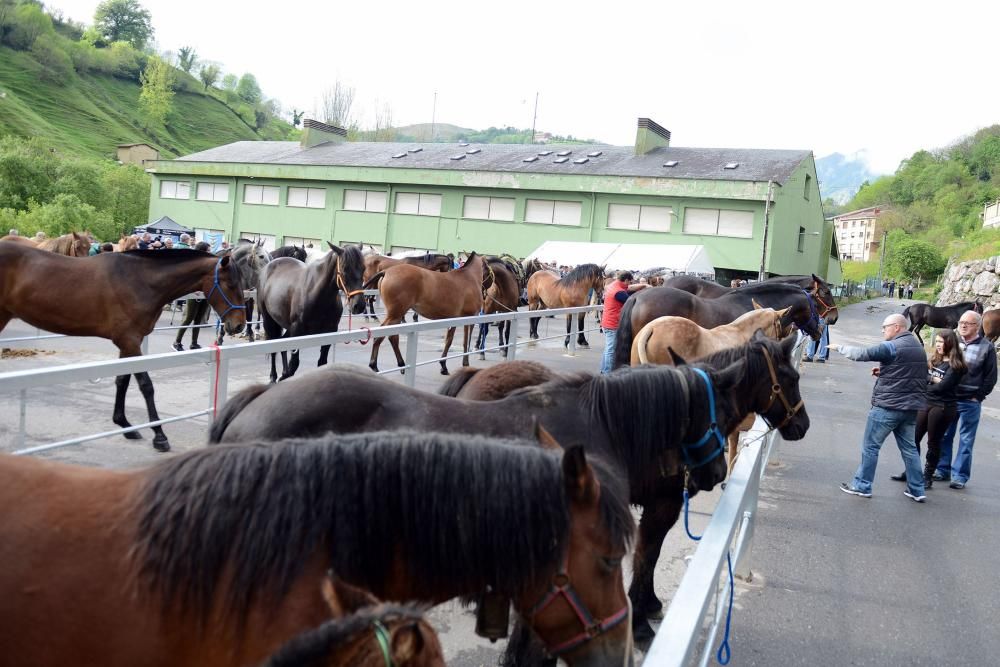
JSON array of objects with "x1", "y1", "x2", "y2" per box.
[{"x1": 892, "y1": 329, "x2": 969, "y2": 489}]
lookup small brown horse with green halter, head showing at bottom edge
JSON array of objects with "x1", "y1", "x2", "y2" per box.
[{"x1": 263, "y1": 573, "x2": 445, "y2": 667}]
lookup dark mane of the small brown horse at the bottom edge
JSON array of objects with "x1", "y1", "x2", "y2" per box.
[{"x1": 263, "y1": 604, "x2": 424, "y2": 667}]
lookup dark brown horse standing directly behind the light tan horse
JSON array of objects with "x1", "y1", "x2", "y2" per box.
[{"x1": 614, "y1": 283, "x2": 820, "y2": 368}]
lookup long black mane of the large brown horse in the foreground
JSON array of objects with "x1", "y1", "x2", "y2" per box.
[{"x1": 131, "y1": 432, "x2": 633, "y2": 620}]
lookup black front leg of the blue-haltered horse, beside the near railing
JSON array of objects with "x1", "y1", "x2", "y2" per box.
[{"x1": 628, "y1": 498, "x2": 683, "y2": 642}]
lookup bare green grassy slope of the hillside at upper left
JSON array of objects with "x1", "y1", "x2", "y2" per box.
[{"x1": 0, "y1": 47, "x2": 274, "y2": 158}]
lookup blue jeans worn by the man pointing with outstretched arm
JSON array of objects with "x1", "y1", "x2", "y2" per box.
[{"x1": 853, "y1": 407, "x2": 924, "y2": 496}]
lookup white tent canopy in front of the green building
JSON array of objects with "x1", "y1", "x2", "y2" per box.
[{"x1": 528, "y1": 241, "x2": 715, "y2": 276}]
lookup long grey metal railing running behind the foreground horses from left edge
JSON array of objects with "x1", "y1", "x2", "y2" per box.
[{"x1": 0, "y1": 306, "x2": 603, "y2": 454}]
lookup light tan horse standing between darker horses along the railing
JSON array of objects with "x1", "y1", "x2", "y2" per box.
[{"x1": 631, "y1": 302, "x2": 790, "y2": 474}]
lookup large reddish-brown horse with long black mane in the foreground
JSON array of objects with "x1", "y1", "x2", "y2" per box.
[{"x1": 0, "y1": 433, "x2": 580, "y2": 667}]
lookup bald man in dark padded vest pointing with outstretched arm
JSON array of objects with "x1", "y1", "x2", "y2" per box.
[{"x1": 830, "y1": 313, "x2": 927, "y2": 503}]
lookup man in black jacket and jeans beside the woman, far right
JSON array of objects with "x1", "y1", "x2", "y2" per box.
[{"x1": 934, "y1": 310, "x2": 997, "y2": 489}]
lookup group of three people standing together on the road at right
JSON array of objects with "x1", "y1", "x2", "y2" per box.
[{"x1": 830, "y1": 310, "x2": 997, "y2": 503}]
